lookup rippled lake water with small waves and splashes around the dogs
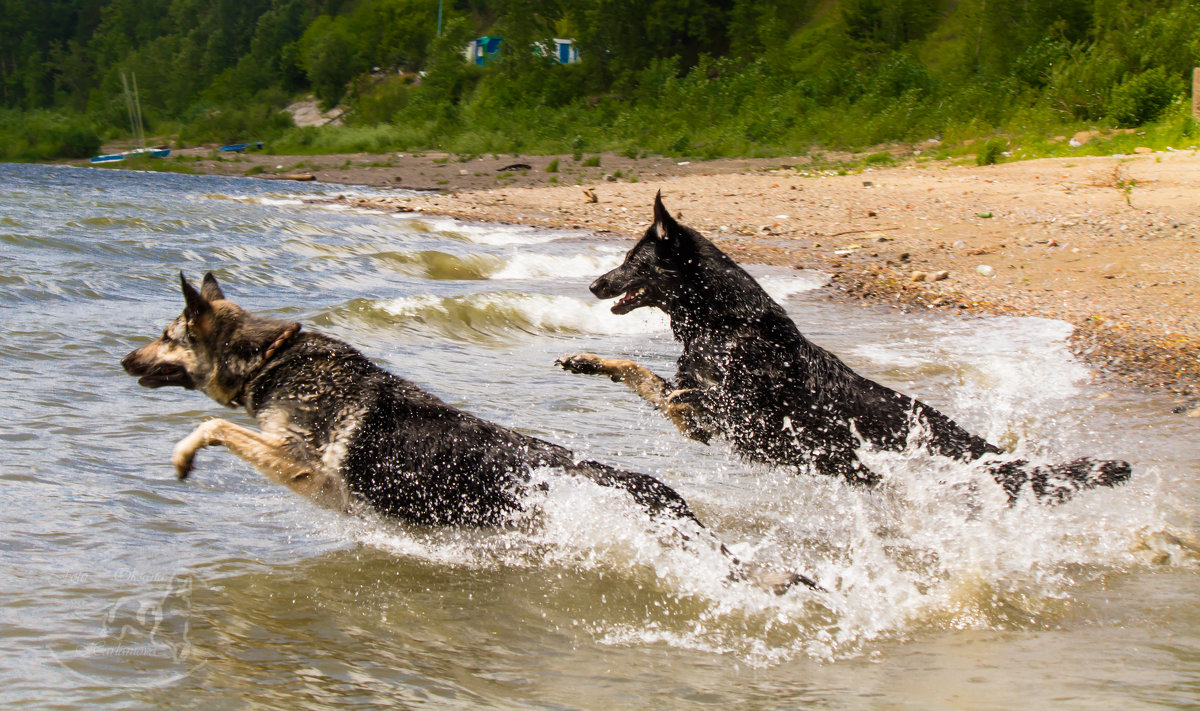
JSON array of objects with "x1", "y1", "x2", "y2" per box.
[{"x1": 0, "y1": 166, "x2": 1200, "y2": 710}]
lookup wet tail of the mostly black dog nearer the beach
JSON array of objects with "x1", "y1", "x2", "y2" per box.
[{"x1": 988, "y1": 456, "x2": 1133, "y2": 504}]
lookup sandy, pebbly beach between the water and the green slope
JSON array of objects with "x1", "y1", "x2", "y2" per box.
[{"x1": 96, "y1": 149, "x2": 1200, "y2": 408}]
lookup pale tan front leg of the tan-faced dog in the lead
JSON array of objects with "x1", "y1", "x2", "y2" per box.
[{"x1": 172, "y1": 419, "x2": 349, "y2": 510}]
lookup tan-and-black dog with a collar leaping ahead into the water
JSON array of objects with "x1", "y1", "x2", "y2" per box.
[{"x1": 121, "y1": 274, "x2": 816, "y2": 592}]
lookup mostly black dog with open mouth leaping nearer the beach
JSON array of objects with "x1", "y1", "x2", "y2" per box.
[{"x1": 558, "y1": 195, "x2": 1130, "y2": 503}]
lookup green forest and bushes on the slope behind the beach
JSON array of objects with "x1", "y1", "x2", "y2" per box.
[{"x1": 0, "y1": 0, "x2": 1200, "y2": 160}]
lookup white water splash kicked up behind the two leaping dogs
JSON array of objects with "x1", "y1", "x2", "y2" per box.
[{"x1": 321, "y1": 447, "x2": 1200, "y2": 667}]
